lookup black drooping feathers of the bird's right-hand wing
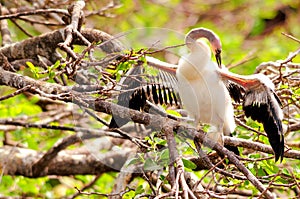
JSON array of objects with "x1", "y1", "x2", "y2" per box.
[{"x1": 224, "y1": 76, "x2": 284, "y2": 161}]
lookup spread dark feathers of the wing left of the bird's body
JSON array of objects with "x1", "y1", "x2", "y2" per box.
[{"x1": 109, "y1": 66, "x2": 181, "y2": 128}]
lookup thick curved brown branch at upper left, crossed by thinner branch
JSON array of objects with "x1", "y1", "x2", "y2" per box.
[{"x1": 0, "y1": 27, "x2": 124, "y2": 65}]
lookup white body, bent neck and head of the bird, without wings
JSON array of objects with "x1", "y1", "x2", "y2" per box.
[{"x1": 176, "y1": 28, "x2": 236, "y2": 148}]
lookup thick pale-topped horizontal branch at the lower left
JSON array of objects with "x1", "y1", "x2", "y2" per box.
[{"x1": 0, "y1": 146, "x2": 131, "y2": 178}]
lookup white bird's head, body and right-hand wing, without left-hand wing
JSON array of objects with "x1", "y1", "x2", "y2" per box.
[{"x1": 176, "y1": 28, "x2": 284, "y2": 162}]
